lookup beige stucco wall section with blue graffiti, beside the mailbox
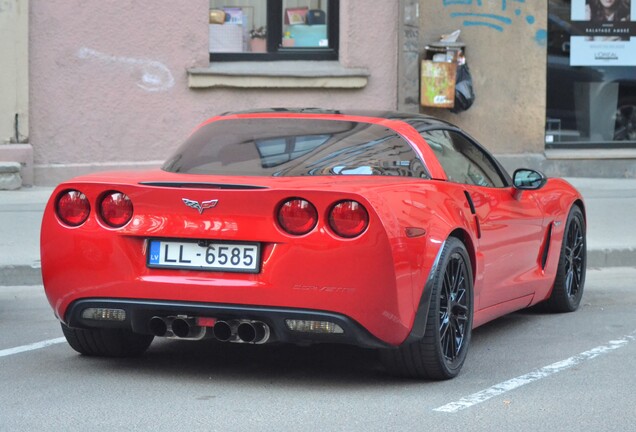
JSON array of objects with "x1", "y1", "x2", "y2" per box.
[{"x1": 420, "y1": 0, "x2": 547, "y2": 153}]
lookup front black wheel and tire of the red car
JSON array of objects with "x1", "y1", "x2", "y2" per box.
[{"x1": 544, "y1": 205, "x2": 587, "y2": 313}]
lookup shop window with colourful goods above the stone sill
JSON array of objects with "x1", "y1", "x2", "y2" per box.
[{"x1": 209, "y1": 0, "x2": 339, "y2": 61}]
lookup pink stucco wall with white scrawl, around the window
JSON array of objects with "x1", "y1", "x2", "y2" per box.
[{"x1": 30, "y1": 0, "x2": 398, "y2": 184}]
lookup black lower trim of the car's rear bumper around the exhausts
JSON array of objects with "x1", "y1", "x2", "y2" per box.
[{"x1": 64, "y1": 298, "x2": 391, "y2": 348}]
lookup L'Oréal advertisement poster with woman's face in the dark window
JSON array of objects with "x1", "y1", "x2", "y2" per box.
[{"x1": 570, "y1": 0, "x2": 636, "y2": 66}]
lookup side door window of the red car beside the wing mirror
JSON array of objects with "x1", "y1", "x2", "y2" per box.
[{"x1": 421, "y1": 129, "x2": 505, "y2": 187}]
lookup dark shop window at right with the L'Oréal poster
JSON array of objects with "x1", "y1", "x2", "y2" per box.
[{"x1": 545, "y1": 0, "x2": 636, "y2": 148}]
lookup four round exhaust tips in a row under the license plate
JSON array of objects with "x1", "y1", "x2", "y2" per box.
[{"x1": 148, "y1": 316, "x2": 271, "y2": 345}]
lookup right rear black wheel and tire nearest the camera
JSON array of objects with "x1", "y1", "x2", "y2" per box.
[{"x1": 381, "y1": 237, "x2": 473, "y2": 380}]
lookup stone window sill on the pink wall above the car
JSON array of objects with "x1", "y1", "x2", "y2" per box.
[{"x1": 188, "y1": 61, "x2": 370, "y2": 89}]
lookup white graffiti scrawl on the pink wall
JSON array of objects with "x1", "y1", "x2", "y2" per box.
[{"x1": 77, "y1": 48, "x2": 174, "y2": 92}]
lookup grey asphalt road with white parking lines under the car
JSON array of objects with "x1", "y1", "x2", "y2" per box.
[{"x1": 0, "y1": 268, "x2": 636, "y2": 432}]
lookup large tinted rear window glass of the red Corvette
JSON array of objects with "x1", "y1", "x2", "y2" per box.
[{"x1": 163, "y1": 118, "x2": 428, "y2": 177}]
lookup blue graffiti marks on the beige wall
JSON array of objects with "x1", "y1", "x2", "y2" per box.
[{"x1": 442, "y1": 0, "x2": 547, "y2": 45}]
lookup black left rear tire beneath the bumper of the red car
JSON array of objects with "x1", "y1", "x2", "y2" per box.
[{"x1": 62, "y1": 324, "x2": 154, "y2": 357}]
